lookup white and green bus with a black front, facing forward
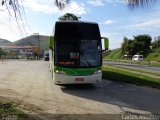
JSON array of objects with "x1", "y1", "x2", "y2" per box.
[{"x1": 49, "y1": 21, "x2": 108, "y2": 84}]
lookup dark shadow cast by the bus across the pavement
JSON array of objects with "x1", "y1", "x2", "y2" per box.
[{"x1": 61, "y1": 80, "x2": 160, "y2": 113}]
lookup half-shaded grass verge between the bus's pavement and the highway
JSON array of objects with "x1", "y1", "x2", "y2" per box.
[{"x1": 102, "y1": 66, "x2": 160, "y2": 88}]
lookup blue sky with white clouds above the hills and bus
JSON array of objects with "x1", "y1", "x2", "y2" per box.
[{"x1": 0, "y1": 0, "x2": 160, "y2": 49}]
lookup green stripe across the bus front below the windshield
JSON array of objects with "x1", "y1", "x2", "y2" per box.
[{"x1": 54, "y1": 66, "x2": 101, "y2": 76}]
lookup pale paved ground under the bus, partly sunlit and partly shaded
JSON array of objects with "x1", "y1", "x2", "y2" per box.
[{"x1": 0, "y1": 61, "x2": 160, "y2": 120}]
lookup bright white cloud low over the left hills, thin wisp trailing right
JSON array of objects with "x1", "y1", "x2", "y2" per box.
[{"x1": 0, "y1": 17, "x2": 46, "y2": 42}]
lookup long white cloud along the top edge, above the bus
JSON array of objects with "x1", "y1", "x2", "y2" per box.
[{"x1": 24, "y1": 0, "x2": 86, "y2": 15}]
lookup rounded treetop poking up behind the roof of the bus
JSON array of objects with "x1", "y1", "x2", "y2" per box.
[{"x1": 58, "y1": 13, "x2": 78, "y2": 21}]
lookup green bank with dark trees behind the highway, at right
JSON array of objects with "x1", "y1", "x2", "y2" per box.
[{"x1": 103, "y1": 34, "x2": 160, "y2": 63}]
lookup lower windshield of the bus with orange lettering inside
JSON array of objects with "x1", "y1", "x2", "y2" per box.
[{"x1": 55, "y1": 40, "x2": 101, "y2": 67}]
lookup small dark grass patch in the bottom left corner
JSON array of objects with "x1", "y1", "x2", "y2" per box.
[{"x1": 0, "y1": 101, "x2": 33, "y2": 120}]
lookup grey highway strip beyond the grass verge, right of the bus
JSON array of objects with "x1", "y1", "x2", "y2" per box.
[{"x1": 103, "y1": 61, "x2": 160, "y2": 73}]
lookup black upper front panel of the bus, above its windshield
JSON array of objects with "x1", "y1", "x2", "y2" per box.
[{"x1": 54, "y1": 21, "x2": 101, "y2": 40}]
